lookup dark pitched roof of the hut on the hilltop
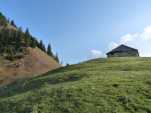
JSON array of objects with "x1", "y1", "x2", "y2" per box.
[{"x1": 107, "y1": 44, "x2": 138, "y2": 54}]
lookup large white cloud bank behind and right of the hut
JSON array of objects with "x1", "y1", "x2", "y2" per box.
[{"x1": 109, "y1": 26, "x2": 151, "y2": 57}]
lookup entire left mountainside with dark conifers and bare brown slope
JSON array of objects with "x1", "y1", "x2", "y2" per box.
[{"x1": 0, "y1": 12, "x2": 61, "y2": 86}]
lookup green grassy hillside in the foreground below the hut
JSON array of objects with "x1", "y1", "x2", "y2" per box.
[{"x1": 0, "y1": 58, "x2": 151, "y2": 113}]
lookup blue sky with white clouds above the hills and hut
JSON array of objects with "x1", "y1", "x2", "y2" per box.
[{"x1": 0, "y1": 0, "x2": 151, "y2": 63}]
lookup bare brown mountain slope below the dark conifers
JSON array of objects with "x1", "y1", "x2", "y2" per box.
[{"x1": 0, "y1": 47, "x2": 61, "y2": 85}]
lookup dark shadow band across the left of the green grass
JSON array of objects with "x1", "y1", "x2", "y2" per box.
[{"x1": 0, "y1": 67, "x2": 86, "y2": 98}]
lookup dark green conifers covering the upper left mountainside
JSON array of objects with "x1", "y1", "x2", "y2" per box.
[{"x1": 0, "y1": 13, "x2": 59, "y2": 62}]
